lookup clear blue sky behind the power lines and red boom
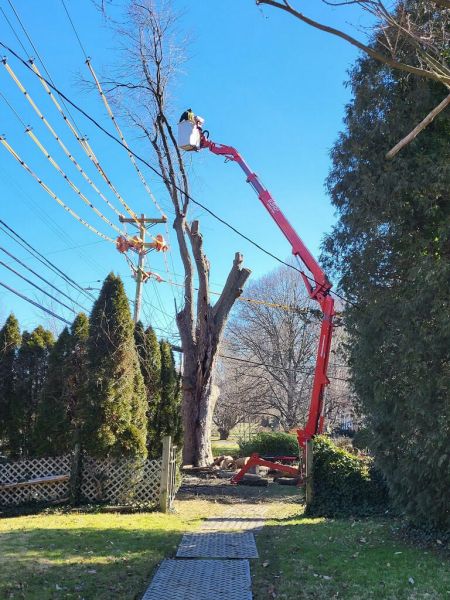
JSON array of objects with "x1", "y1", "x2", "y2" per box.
[{"x1": 0, "y1": 0, "x2": 368, "y2": 340}]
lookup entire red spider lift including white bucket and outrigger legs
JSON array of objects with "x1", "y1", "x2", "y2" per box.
[{"x1": 178, "y1": 111, "x2": 335, "y2": 483}]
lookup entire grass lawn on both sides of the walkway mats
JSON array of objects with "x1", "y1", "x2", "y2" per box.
[{"x1": 0, "y1": 485, "x2": 450, "y2": 600}]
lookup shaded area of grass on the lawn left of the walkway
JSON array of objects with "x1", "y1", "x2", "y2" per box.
[{"x1": 0, "y1": 527, "x2": 182, "y2": 600}]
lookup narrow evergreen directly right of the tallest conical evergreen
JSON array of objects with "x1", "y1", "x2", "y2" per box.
[{"x1": 134, "y1": 322, "x2": 161, "y2": 458}]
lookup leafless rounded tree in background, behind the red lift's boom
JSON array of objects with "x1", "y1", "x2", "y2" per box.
[{"x1": 227, "y1": 267, "x2": 319, "y2": 431}]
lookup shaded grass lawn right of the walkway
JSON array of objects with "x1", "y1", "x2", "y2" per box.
[{"x1": 252, "y1": 516, "x2": 450, "y2": 600}]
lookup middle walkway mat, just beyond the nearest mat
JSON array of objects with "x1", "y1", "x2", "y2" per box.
[{"x1": 177, "y1": 532, "x2": 258, "y2": 558}]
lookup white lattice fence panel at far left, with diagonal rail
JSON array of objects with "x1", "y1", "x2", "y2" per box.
[{"x1": 0, "y1": 455, "x2": 70, "y2": 506}]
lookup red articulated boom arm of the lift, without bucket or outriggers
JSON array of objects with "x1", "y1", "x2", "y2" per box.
[{"x1": 200, "y1": 134, "x2": 334, "y2": 448}]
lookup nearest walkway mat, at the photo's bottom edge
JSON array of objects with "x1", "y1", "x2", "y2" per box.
[{"x1": 142, "y1": 559, "x2": 252, "y2": 600}]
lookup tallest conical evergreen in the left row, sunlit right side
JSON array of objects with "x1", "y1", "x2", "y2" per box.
[{"x1": 82, "y1": 273, "x2": 147, "y2": 457}]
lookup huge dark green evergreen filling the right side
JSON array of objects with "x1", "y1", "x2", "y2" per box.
[{"x1": 325, "y1": 11, "x2": 450, "y2": 529}]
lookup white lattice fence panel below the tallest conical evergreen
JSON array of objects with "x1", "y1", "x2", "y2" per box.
[{"x1": 81, "y1": 457, "x2": 161, "y2": 504}]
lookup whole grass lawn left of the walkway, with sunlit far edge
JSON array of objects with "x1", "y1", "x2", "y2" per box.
[{"x1": 0, "y1": 510, "x2": 204, "y2": 600}]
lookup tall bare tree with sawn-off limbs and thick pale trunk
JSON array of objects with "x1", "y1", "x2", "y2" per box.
[{"x1": 105, "y1": 0, "x2": 250, "y2": 465}]
